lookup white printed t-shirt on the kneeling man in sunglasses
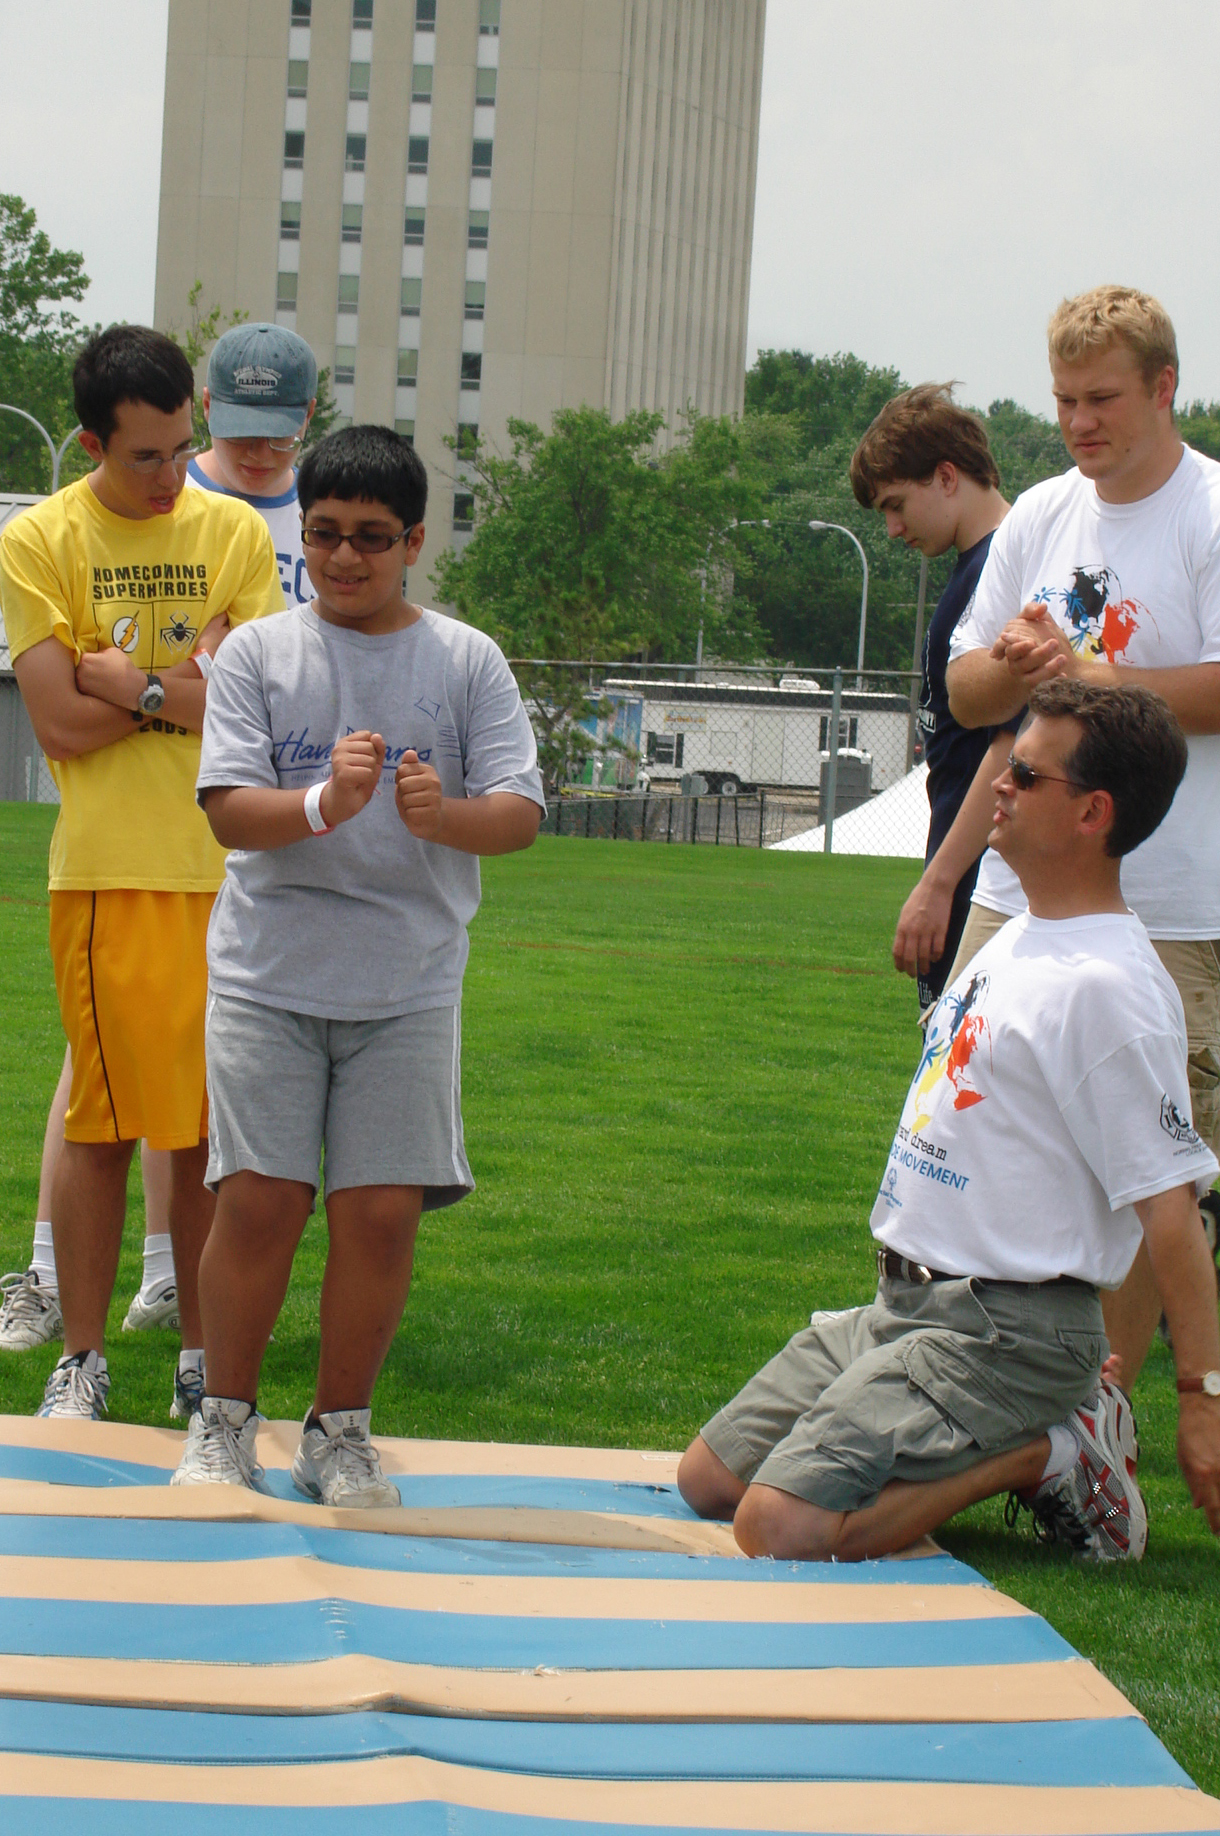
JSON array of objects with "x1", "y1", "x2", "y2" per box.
[{"x1": 871, "y1": 912, "x2": 1220, "y2": 1287}]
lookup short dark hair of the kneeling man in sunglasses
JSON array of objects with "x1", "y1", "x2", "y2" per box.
[{"x1": 1029, "y1": 676, "x2": 1187, "y2": 859}]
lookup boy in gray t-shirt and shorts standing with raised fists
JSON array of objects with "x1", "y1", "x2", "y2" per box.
[{"x1": 173, "y1": 426, "x2": 546, "y2": 1506}]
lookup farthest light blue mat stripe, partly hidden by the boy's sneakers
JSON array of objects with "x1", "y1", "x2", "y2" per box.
[{"x1": 0, "y1": 1443, "x2": 698, "y2": 1524}]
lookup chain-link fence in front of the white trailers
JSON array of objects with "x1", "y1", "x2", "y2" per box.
[{"x1": 513, "y1": 659, "x2": 928, "y2": 859}]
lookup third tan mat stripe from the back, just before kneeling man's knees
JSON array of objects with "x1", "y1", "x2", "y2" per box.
[{"x1": 0, "y1": 1555, "x2": 1034, "y2": 1625}]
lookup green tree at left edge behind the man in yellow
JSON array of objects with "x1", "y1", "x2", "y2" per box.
[{"x1": 0, "y1": 193, "x2": 88, "y2": 492}]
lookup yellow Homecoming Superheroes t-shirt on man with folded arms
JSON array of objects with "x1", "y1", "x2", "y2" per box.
[{"x1": 0, "y1": 479, "x2": 283, "y2": 892}]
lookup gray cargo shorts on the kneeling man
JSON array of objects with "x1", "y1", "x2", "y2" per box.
[{"x1": 704, "y1": 1278, "x2": 1108, "y2": 1511}]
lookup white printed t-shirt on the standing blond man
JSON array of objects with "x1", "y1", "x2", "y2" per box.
[{"x1": 950, "y1": 446, "x2": 1220, "y2": 938}]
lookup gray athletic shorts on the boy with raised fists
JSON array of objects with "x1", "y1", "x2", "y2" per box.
[{"x1": 204, "y1": 993, "x2": 474, "y2": 1212}]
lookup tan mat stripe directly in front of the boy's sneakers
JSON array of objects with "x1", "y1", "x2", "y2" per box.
[{"x1": 0, "y1": 1480, "x2": 744, "y2": 1561}]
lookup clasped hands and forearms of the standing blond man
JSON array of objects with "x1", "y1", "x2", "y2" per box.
[{"x1": 944, "y1": 602, "x2": 1220, "y2": 733}]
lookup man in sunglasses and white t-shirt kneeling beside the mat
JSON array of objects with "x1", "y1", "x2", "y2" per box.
[{"x1": 678, "y1": 679, "x2": 1220, "y2": 1561}]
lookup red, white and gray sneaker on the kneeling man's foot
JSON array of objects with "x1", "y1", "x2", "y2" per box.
[{"x1": 1005, "y1": 1379, "x2": 1148, "y2": 1562}]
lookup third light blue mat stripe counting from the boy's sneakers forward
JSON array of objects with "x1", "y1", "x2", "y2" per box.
[{"x1": 0, "y1": 1600, "x2": 1075, "y2": 1671}]
